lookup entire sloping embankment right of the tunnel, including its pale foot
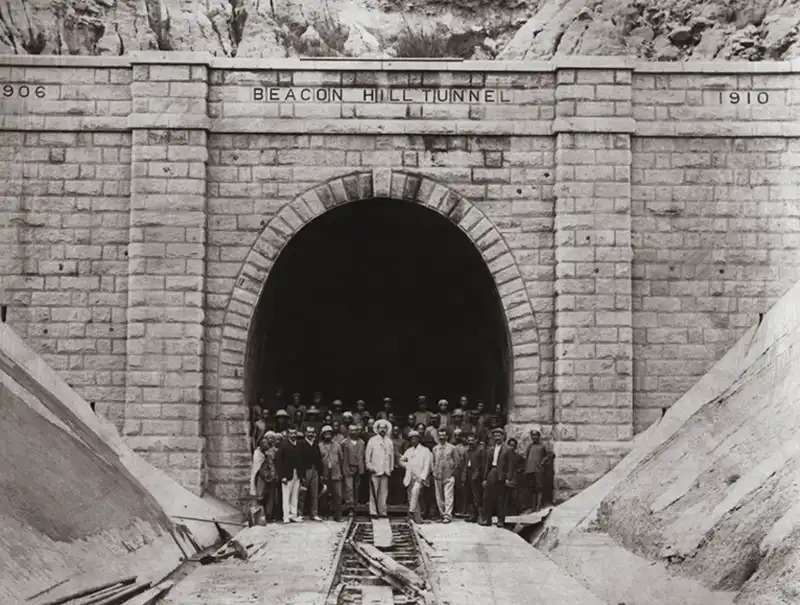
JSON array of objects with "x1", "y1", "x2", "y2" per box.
[{"x1": 535, "y1": 284, "x2": 800, "y2": 605}]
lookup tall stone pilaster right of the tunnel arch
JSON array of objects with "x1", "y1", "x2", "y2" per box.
[{"x1": 555, "y1": 69, "x2": 633, "y2": 497}]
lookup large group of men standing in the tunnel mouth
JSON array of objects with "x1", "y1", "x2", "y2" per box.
[{"x1": 250, "y1": 391, "x2": 554, "y2": 525}]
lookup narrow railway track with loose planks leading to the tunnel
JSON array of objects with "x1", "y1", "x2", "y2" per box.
[{"x1": 325, "y1": 516, "x2": 425, "y2": 605}]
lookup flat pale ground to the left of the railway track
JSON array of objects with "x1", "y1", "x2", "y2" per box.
[{"x1": 160, "y1": 521, "x2": 346, "y2": 605}]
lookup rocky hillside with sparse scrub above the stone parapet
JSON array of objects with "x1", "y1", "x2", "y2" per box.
[{"x1": 0, "y1": 0, "x2": 800, "y2": 61}]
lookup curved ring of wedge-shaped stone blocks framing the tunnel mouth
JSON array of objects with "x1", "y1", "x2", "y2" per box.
[{"x1": 217, "y1": 168, "x2": 539, "y2": 407}]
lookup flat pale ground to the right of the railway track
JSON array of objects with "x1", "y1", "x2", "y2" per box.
[{"x1": 419, "y1": 522, "x2": 605, "y2": 605}]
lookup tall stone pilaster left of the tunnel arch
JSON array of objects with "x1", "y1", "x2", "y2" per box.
[{"x1": 124, "y1": 53, "x2": 208, "y2": 494}]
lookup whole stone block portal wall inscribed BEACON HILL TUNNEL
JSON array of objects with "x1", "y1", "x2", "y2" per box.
[{"x1": 0, "y1": 53, "x2": 800, "y2": 501}]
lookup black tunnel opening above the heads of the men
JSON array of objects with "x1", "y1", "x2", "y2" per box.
[{"x1": 245, "y1": 199, "x2": 510, "y2": 418}]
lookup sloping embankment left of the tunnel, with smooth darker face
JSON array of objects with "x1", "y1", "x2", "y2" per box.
[{"x1": 0, "y1": 324, "x2": 239, "y2": 605}]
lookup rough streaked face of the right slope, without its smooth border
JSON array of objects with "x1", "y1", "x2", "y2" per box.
[{"x1": 598, "y1": 285, "x2": 800, "y2": 605}]
